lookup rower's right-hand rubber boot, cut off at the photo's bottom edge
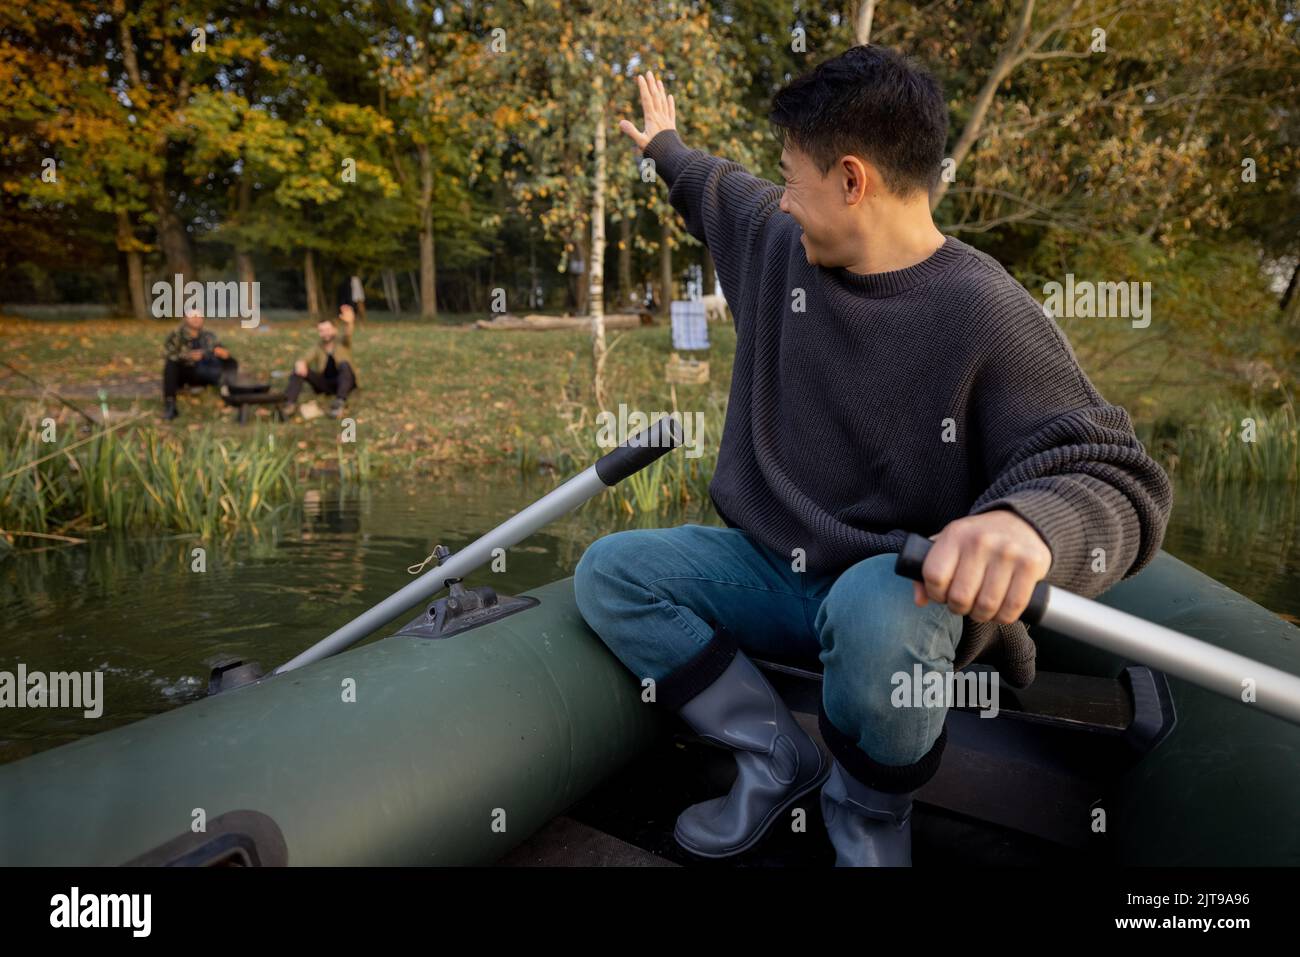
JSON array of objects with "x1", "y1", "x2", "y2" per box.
[{"x1": 822, "y1": 761, "x2": 911, "y2": 867}]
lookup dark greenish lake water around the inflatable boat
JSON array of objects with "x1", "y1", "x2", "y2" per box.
[{"x1": 0, "y1": 476, "x2": 1300, "y2": 763}]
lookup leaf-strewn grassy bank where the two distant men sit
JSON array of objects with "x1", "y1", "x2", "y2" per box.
[{"x1": 0, "y1": 313, "x2": 735, "y2": 475}]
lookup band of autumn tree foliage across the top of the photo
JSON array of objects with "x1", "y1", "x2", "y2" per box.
[{"x1": 0, "y1": 0, "x2": 1300, "y2": 321}]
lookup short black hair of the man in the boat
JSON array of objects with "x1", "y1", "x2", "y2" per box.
[{"x1": 770, "y1": 46, "x2": 948, "y2": 195}]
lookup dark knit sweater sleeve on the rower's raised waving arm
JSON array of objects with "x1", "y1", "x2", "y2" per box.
[{"x1": 645, "y1": 130, "x2": 788, "y2": 312}]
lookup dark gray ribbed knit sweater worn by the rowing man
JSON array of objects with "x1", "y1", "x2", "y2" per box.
[{"x1": 646, "y1": 130, "x2": 1173, "y2": 687}]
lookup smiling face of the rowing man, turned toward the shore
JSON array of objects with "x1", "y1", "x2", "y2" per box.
[{"x1": 780, "y1": 143, "x2": 862, "y2": 269}]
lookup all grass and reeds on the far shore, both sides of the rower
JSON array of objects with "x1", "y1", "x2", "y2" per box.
[{"x1": 0, "y1": 240, "x2": 1300, "y2": 547}]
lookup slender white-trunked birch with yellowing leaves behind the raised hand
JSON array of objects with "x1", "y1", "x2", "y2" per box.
[{"x1": 489, "y1": 0, "x2": 750, "y2": 407}]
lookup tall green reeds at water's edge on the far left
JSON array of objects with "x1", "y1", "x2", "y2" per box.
[{"x1": 0, "y1": 413, "x2": 298, "y2": 536}]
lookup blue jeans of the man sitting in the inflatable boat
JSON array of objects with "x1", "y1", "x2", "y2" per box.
[{"x1": 575, "y1": 525, "x2": 962, "y2": 766}]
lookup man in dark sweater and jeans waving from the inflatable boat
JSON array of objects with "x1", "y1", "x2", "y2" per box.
[{"x1": 576, "y1": 47, "x2": 1171, "y2": 866}]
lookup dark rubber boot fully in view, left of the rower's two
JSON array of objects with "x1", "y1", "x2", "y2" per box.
[{"x1": 673, "y1": 651, "x2": 831, "y2": 857}]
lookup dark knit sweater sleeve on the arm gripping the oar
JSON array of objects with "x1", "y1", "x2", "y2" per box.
[{"x1": 971, "y1": 302, "x2": 1173, "y2": 597}]
